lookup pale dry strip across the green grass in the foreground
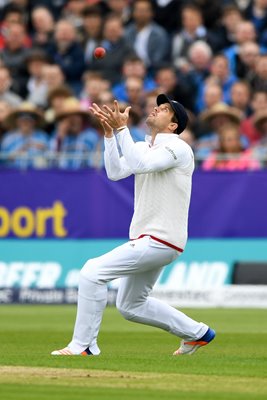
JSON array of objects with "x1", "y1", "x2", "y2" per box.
[{"x1": 0, "y1": 366, "x2": 267, "y2": 394}]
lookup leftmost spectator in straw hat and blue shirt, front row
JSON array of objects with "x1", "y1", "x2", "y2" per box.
[{"x1": 1, "y1": 102, "x2": 48, "y2": 168}]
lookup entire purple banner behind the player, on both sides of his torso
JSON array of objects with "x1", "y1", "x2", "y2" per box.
[{"x1": 0, "y1": 169, "x2": 267, "y2": 239}]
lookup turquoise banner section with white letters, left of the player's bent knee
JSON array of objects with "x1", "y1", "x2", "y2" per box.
[{"x1": 0, "y1": 240, "x2": 123, "y2": 289}]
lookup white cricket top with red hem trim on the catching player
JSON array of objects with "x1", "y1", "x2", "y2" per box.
[{"x1": 104, "y1": 128, "x2": 194, "y2": 251}]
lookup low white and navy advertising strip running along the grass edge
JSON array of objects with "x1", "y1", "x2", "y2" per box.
[{"x1": 0, "y1": 285, "x2": 267, "y2": 308}]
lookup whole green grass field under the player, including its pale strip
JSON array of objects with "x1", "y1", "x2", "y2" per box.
[{"x1": 0, "y1": 305, "x2": 267, "y2": 400}]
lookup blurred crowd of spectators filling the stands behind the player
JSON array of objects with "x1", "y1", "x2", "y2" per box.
[{"x1": 0, "y1": 0, "x2": 267, "y2": 170}]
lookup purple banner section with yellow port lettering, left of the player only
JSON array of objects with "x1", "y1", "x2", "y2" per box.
[{"x1": 0, "y1": 169, "x2": 133, "y2": 239}]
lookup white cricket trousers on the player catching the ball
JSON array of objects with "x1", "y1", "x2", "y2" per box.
[{"x1": 68, "y1": 236, "x2": 208, "y2": 355}]
